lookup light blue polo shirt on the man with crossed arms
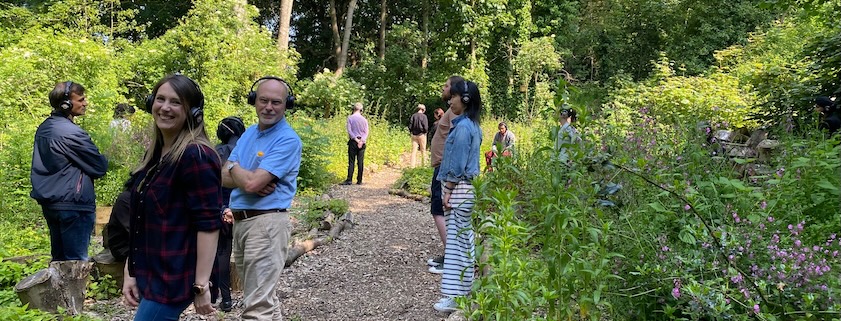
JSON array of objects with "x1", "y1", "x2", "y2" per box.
[{"x1": 228, "y1": 117, "x2": 303, "y2": 210}]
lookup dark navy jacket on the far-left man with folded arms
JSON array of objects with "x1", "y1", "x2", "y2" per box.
[{"x1": 29, "y1": 112, "x2": 108, "y2": 211}]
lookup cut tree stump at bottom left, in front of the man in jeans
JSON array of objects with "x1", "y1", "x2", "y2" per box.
[{"x1": 15, "y1": 261, "x2": 93, "y2": 315}]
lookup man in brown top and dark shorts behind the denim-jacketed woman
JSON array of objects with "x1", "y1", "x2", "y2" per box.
[{"x1": 426, "y1": 76, "x2": 464, "y2": 274}]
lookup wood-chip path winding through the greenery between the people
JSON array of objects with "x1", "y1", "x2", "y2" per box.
[{"x1": 280, "y1": 169, "x2": 446, "y2": 321}]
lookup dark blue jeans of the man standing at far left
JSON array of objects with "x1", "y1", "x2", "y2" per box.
[{"x1": 43, "y1": 208, "x2": 96, "y2": 261}]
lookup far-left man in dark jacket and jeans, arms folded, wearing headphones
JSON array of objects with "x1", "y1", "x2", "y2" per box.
[{"x1": 29, "y1": 81, "x2": 108, "y2": 261}]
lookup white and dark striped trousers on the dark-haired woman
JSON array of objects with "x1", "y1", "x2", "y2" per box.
[{"x1": 441, "y1": 181, "x2": 476, "y2": 297}]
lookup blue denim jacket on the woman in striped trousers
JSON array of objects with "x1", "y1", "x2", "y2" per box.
[{"x1": 437, "y1": 114, "x2": 482, "y2": 183}]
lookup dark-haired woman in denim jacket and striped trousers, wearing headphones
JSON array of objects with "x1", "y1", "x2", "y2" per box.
[{"x1": 433, "y1": 81, "x2": 482, "y2": 312}]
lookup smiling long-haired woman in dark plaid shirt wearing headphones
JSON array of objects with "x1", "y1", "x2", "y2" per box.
[{"x1": 123, "y1": 74, "x2": 222, "y2": 321}]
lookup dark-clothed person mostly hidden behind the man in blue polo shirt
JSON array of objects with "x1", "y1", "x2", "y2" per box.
[{"x1": 210, "y1": 116, "x2": 245, "y2": 312}]
